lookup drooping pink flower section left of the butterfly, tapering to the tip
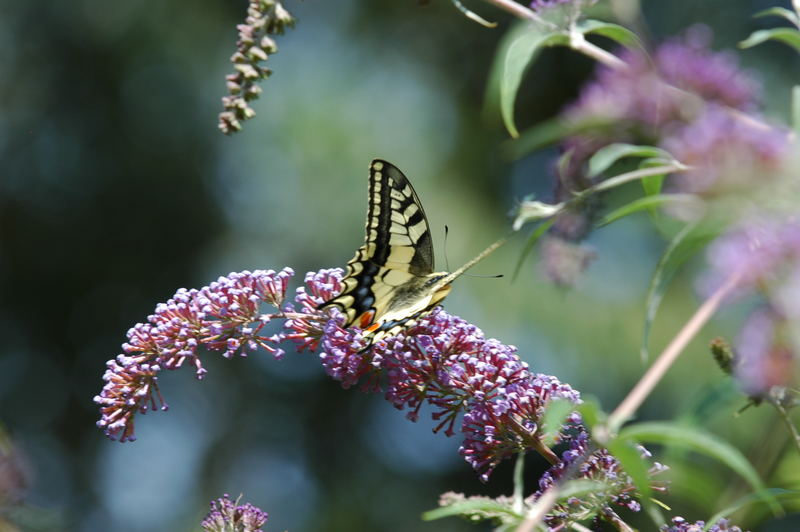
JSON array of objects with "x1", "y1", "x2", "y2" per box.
[{"x1": 94, "y1": 268, "x2": 294, "y2": 441}]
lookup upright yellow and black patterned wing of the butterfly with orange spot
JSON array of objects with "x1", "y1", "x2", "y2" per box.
[{"x1": 320, "y1": 159, "x2": 433, "y2": 328}]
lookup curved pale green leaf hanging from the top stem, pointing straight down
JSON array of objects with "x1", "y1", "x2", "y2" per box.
[{"x1": 500, "y1": 24, "x2": 569, "y2": 138}]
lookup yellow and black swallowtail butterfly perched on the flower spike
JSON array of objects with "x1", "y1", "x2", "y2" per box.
[{"x1": 318, "y1": 159, "x2": 505, "y2": 349}]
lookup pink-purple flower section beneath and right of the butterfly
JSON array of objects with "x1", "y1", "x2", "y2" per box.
[{"x1": 287, "y1": 270, "x2": 580, "y2": 480}]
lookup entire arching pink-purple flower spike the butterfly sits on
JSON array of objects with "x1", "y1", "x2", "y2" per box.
[{"x1": 95, "y1": 268, "x2": 656, "y2": 524}]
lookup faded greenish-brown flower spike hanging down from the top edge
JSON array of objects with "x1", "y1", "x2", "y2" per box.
[{"x1": 219, "y1": 0, "x2": 294, "y2": 134}]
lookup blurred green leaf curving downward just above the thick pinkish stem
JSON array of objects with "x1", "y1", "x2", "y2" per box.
[{"x1": 641, "y1": 223, "x2": 722, "y2": 360}]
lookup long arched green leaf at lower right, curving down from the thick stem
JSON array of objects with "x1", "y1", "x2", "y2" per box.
[{"x1": 618, "y1": 421, "x2": 778, "y2": 506}]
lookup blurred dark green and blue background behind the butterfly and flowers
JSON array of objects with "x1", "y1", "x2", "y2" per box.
[{"x1": 0, "y1": 0, "x2": 800, "y2": 532}]
